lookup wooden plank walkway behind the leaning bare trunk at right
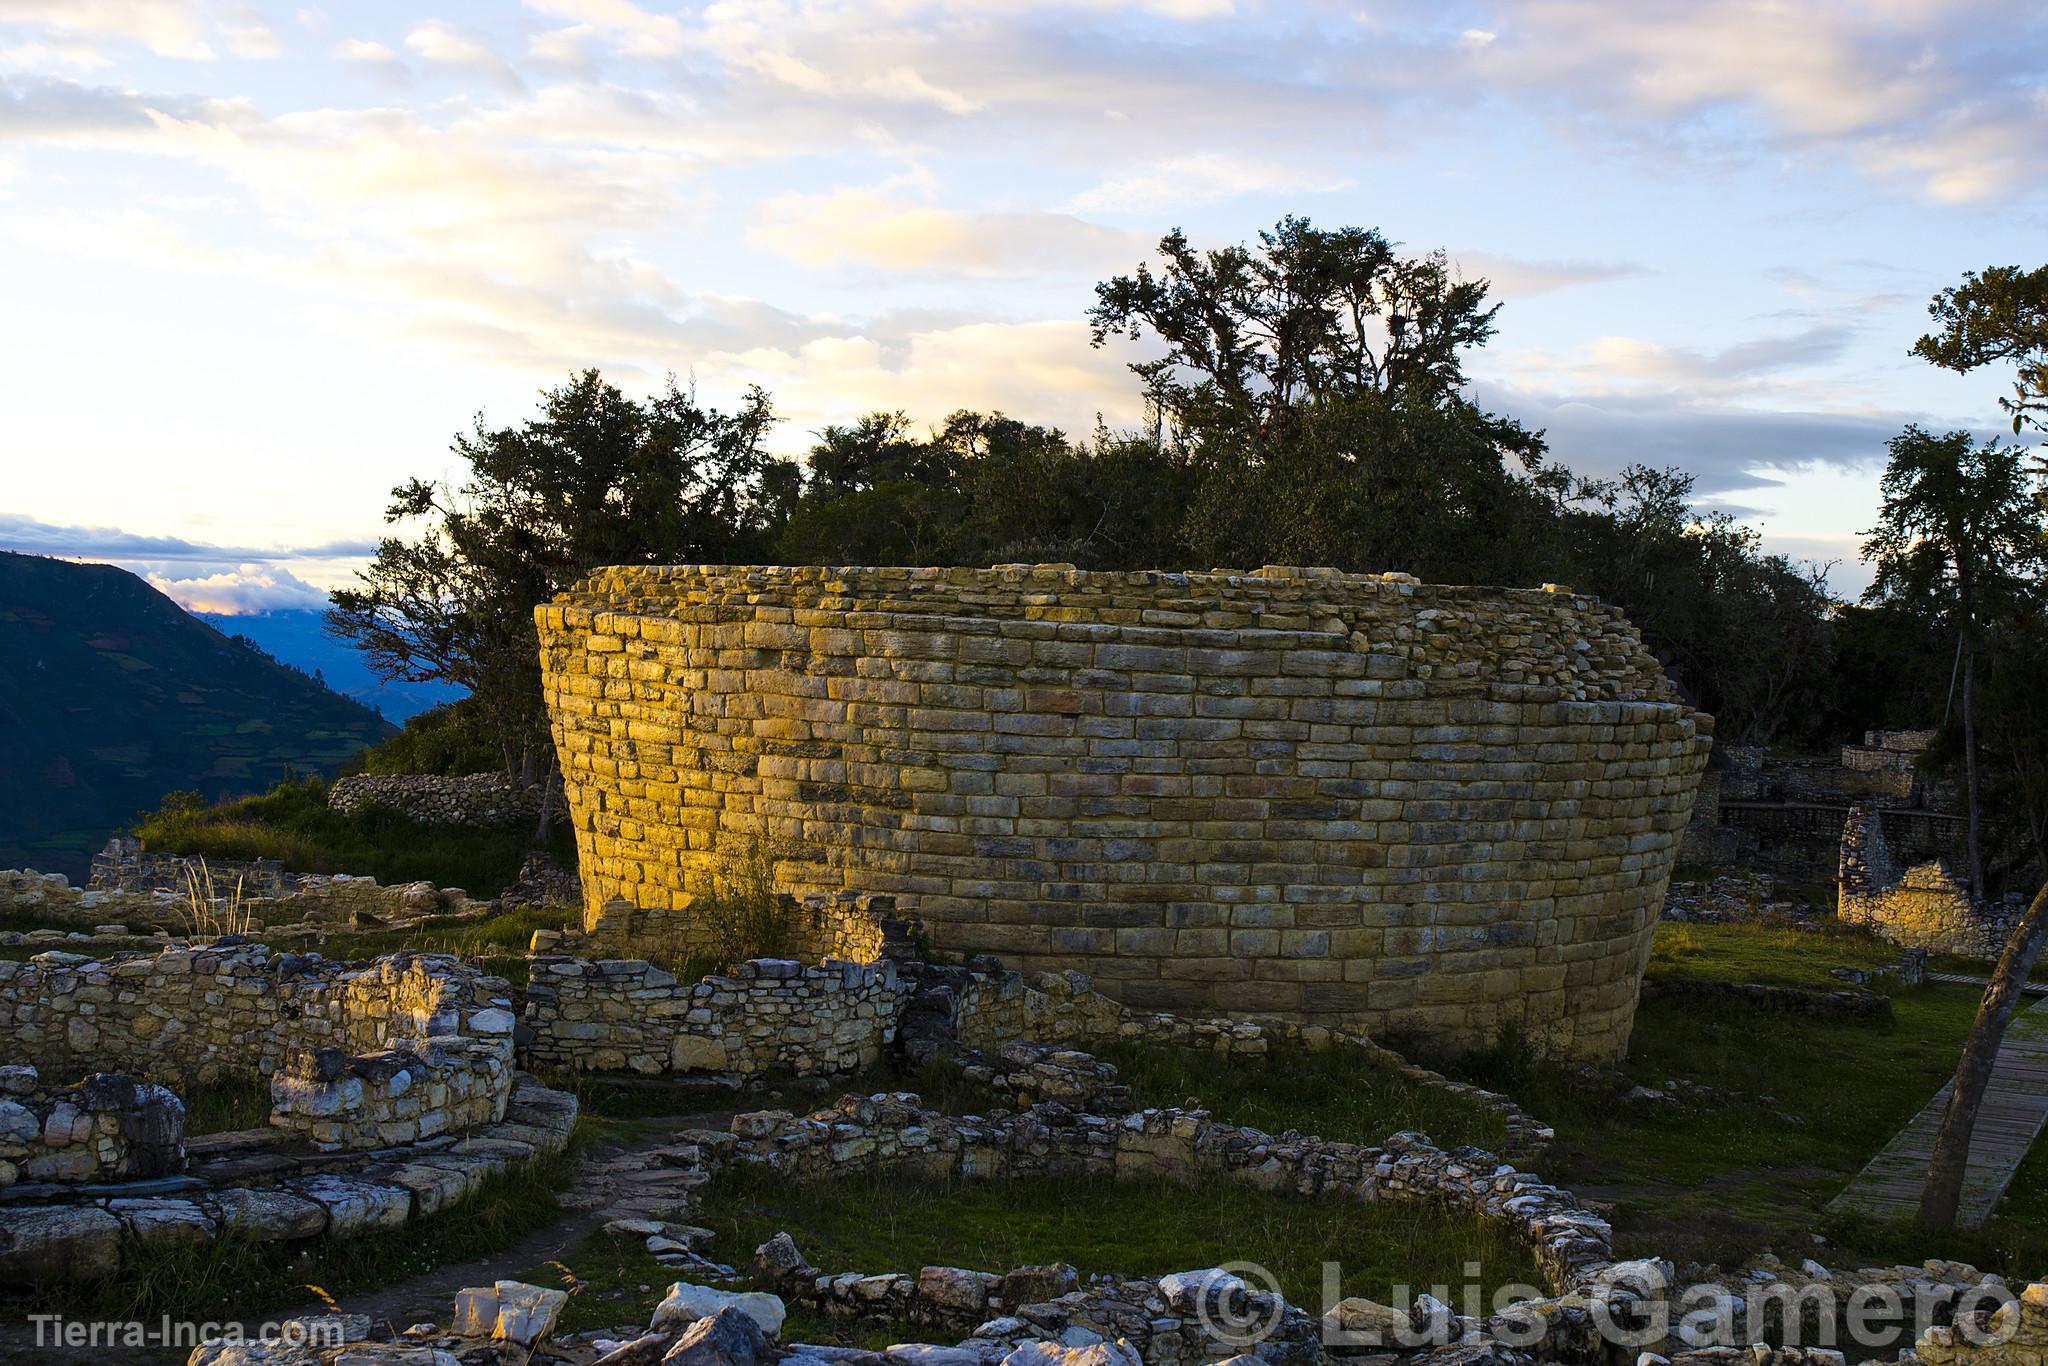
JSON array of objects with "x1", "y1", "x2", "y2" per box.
[{"x1": 1829, "y1": 999, "x2": 2048, "y2": 1229}]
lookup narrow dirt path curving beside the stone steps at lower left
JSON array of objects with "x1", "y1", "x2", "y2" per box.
[{"x1": 0, "y1": 1112, "x2": 733, "y2": 1366}]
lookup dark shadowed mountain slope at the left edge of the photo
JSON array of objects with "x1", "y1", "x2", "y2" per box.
[{"x1": 0, "y1": 553, "x2": 391, "y2": 879}]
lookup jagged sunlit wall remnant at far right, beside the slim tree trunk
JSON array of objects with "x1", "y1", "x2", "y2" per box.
[{"x1": 1835, "y1": 807, "x2": 2019, "y2": 961}]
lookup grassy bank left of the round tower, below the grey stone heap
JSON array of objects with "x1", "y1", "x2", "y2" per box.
[{"x1": 135, "y1": 778, "x2": 575, "y2": 897}]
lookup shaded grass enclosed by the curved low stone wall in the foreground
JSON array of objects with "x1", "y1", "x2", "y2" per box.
[{"x1": 567, "y1": 1167, "x2": 1542, "y2": 1346}]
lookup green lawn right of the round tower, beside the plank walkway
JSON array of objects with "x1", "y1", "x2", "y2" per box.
[{"x1": 1456, "y1": 926, "x2": 2048, "y2": 1276}]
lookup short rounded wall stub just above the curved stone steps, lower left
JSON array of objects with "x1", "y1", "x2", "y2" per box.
[{"x1": 270, "y1": 1038, "x2": 512, "y2": 1151}]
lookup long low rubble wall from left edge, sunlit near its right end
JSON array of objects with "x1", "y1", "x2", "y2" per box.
[{"x1": 0, "y1": 942, "x2": 514, "y2": 1079}]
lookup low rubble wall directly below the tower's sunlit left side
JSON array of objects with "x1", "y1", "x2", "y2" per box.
[{"x1": 526, "y1": 956, "x2": 907, "y2": 1075}]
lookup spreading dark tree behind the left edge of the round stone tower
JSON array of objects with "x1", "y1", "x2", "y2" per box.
[{"x1": 328, "y1": 371, "x2": 793, "y2": 827}]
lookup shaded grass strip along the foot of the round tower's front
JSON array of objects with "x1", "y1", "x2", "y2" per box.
[{"x1": 1096, "y1": 1044, "x2": 1507, "y2": 1153}]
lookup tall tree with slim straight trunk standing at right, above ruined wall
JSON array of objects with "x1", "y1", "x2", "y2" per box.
[{"x1": 1864, "y1": 426, "x2": 2042, "y2": 895}]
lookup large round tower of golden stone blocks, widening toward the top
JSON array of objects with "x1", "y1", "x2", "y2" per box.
[{"x1": 537, "y1": 565, "x2": 1712, "y2": 1057}]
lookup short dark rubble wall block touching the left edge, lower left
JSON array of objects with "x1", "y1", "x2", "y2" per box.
[{"x1": 0, "y1": 1063, "x2": 184, "y2": 1188}]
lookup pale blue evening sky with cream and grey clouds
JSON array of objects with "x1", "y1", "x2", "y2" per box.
[{"x1": 0, "y1": 0, "x2": 2048, "y2": 612}]
